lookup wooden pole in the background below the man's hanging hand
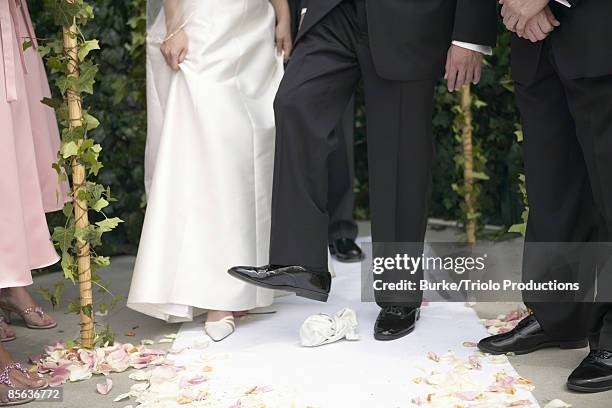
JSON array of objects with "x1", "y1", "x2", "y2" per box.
[{"x1": 461, "y1": 85, "x2": 476, "y2": 244}]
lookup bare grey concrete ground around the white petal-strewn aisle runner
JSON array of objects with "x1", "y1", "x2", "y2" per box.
[{"x1": 4, "y1": 223, "x2": 612, "y2": 408}]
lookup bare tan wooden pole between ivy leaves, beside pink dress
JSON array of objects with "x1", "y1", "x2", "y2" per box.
[{"x1": 63, "y1": 11, "x2": 94, "y2": 348}]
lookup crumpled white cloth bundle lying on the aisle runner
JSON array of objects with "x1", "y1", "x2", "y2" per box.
[{"x1": 300, "y1": 307, "x2": 359, "y2": 347}]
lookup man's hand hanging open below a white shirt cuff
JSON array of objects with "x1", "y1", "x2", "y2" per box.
[{"x1": 444, "y1": 45, "x2": 482, "y2": 92}]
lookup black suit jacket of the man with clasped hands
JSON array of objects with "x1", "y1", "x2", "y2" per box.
[{"x1": 512, "y1": 0, "x2": 612, "y2": 84}]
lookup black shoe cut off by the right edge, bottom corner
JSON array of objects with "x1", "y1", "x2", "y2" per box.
[{"x1": 567, "y1": 350, "x2": 612, "y2": 392}]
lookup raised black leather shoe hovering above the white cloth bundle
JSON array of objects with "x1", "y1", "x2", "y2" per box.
[{"x1": 227, "y1": 265, "x2": 331, "y2": 302}]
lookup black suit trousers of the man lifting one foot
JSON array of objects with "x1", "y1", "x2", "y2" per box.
[{"x1": 270, "y1": 2, "x2": 435, "y2": 306}]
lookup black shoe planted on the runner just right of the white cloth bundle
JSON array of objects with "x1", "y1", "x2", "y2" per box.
[{"x1": 374, "y1": 306, "x2": 421, "y2": 340}]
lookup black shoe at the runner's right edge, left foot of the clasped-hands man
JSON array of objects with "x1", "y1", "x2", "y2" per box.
[{"x1": 478, "y1": 315, "x2": 588, "y2": 354}]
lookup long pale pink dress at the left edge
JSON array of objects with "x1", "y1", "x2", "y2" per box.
[{"x1": 0, "y1": 0, "x2": 67, "y2": 288}]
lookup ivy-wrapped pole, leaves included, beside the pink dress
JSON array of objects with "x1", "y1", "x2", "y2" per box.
[{"x1": 35, "y1": 0, "x2": 123, "y2": 347}]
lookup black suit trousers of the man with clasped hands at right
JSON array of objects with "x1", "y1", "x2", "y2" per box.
[{"x1": 515, "y1": 41, "x2": 612, "y2": 350}]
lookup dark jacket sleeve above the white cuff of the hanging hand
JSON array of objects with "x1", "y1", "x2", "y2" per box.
[{"x1": 453, "y1": 0, "x2": 500, "y2": 47}]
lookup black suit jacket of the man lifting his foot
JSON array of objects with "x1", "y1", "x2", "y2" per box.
[{"x1": 296, "y1": 0, "x2": 497, "y2": 80}]
